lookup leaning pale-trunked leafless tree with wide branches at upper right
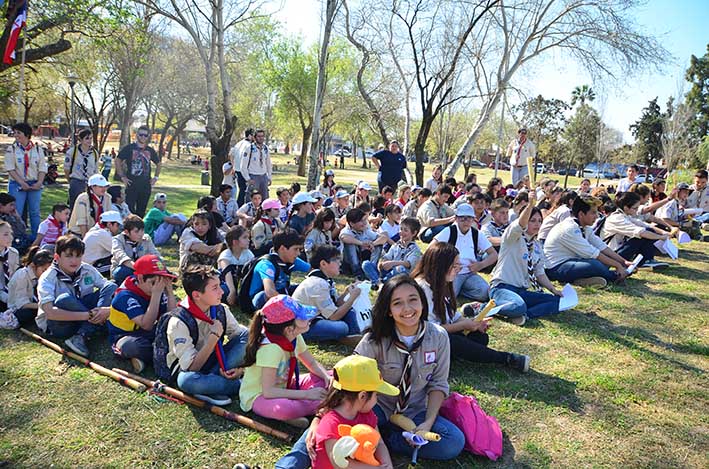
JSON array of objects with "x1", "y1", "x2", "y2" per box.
[{"x1": 446, "y1": 0, "x2": 668, "y2": 176}]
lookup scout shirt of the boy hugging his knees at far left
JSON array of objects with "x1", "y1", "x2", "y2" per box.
[{"x1": 35, "y1": 262, "x2": 108, "y2": 332}]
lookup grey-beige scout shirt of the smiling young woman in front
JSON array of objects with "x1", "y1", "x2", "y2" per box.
[{"x1": 354, "y1": 322, "x2": 450, "y2": 418}]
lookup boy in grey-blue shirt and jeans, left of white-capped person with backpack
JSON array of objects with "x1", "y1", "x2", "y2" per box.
[{"x1": 362, "y1": 217, "x2": 421, "y2": 290}]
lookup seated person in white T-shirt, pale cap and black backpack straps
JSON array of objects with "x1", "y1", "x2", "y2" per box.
[{"x1": 431, "y1": 204, "x2": 497, "y2": 301}]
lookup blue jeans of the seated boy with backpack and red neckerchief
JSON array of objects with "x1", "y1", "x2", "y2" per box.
[{"x1": 177, "y1": 327, "x2": 249, "y2": 396}]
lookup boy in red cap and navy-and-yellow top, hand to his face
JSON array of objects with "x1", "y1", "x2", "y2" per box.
[{"x1": 108, "y1": 254, "x2": 177, "y2": 373}]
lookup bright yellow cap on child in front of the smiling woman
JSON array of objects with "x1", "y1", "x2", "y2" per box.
[{"x1": 332, "y1": 355, "x2": 399, "y2": 396}]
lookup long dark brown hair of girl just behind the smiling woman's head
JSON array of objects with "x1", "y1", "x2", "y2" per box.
[{"x1": 411, "y1": 243, "x2": 459, "y2": 324}]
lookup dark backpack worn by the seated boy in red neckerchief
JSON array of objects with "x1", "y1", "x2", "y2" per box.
[{"x1": 153, "y1": 305, "x2": 226, "y2": 384}]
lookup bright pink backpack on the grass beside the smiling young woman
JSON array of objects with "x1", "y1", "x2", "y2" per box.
[{"x1": 440, "y1": 392, "x2": 502, "y2": 461}]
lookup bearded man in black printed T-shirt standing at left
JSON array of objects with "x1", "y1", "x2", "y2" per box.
[{"x1": 116, "y1": 125, "x2": 161, "y2": 218}]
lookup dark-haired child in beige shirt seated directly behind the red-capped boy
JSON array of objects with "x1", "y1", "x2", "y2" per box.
[{"x1": 111, "y1": 214, "x2": 160, "y2": 285}]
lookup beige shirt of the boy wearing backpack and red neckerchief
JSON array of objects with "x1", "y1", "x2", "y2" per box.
[{"x1": 166, "y1": 305, "x2": 243, "y2": 371}]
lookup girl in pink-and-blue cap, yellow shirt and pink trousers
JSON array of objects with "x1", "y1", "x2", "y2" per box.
[{"x1": 239, "y1": 295, "x2": 330, "y2": 428}]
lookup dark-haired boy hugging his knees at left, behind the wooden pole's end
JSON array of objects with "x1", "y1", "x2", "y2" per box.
[{"x1": 36, "y1": 235, "x2": 116, "y2": 356}]
